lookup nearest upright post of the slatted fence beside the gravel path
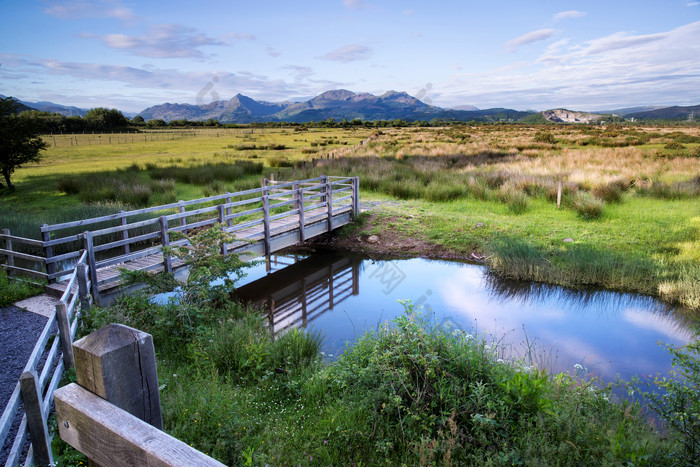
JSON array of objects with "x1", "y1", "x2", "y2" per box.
[{"x1": 19, "y1": 371, "x2": 54, "y2": 467}]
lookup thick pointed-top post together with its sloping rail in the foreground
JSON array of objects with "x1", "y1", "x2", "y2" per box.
[{"x1": 55, "y1": 324, "x2": 223, "y2": 467}]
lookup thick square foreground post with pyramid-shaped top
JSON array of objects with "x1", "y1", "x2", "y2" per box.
[{"x1": 73, "y1": 324, "x2": 163, "y2": 430}]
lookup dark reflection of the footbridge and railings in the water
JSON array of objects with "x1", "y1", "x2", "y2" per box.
[{"x1": 236, "y1": 253, "x2": 360, "y2": 334}]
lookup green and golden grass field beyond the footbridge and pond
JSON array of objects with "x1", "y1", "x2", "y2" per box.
[{"x1": 0, "y1": 125, "x2": 700, "y2": 311}]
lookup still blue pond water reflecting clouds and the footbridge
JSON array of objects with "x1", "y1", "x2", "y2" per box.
[{"x1": 237, "y1": 253, "x2": 693, "y2": 381}]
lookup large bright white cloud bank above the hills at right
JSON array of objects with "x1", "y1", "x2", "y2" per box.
[{"x1": 436, "y1": 21, "x2": 700, "y2": 110}]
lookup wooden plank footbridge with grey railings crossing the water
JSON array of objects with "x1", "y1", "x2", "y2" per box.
[{"x1": 0, "y1": 175, "x2": 359, "y2": 301}]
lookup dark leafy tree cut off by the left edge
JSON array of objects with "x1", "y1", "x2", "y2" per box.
[{"x1": 0, "y1": 97, "x2": 46, "y2": 190}]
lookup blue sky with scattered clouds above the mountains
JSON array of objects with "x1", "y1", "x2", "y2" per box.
[{"x1": 0, "y1": 0, "x2": 700, "y2": 113}]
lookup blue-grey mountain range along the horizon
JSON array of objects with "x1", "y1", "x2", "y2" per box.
[{"x1": 0, "y1": 89, "x2": 700, "y2": 123}]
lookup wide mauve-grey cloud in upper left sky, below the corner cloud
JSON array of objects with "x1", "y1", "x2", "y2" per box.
[{"x1": 85, "y1": 24, "x2": 226, "y2": 59}]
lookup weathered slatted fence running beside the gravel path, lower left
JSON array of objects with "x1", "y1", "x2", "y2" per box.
[{"x1": 0, "y1": 252, "x2": 90, "y2": 467}]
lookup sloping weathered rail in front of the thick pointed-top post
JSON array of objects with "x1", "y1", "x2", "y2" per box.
[{"x1": 54, "y1": 383, "x2": 224, "y2": 467}]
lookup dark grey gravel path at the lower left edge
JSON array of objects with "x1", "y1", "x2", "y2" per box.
[{"x1": 0, "y1": 306, "x2": 46, "y2": 465}]
